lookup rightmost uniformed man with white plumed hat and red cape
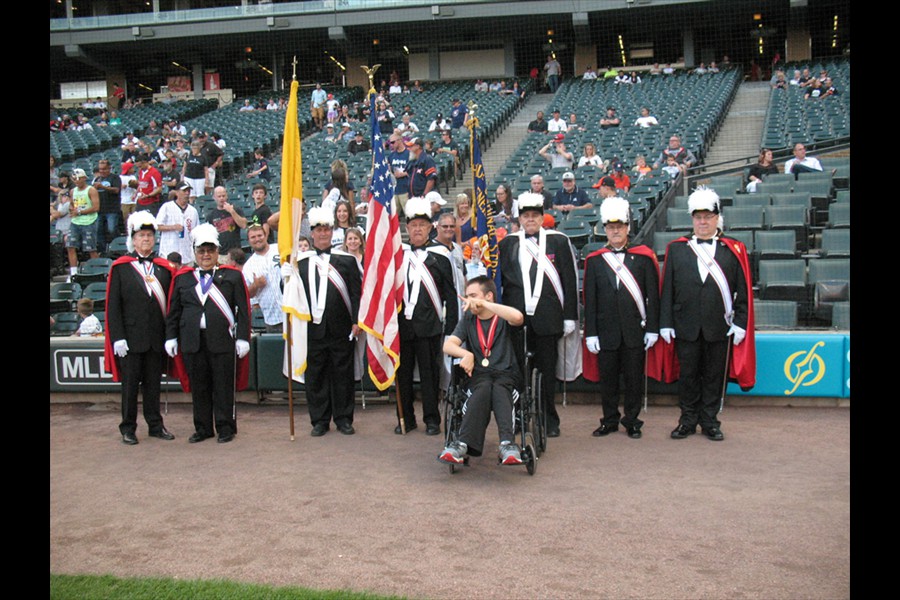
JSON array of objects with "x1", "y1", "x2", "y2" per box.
[{"x1": 659, "y1": 188, "x2": 756, "y2": 441}]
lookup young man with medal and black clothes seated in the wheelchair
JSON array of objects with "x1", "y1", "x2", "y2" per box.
[{"x1": 439, "y1": 275, "x2": 524, "y2": 465}]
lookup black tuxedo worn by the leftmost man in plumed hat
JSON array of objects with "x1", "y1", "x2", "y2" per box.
[{"x1": 106, "y1": 252, "x2": 172, "y2": 434}]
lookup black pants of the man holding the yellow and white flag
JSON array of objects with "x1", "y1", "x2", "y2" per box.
[{"x1": 306, "y1": 336, "x2": 355, "y2": 426}]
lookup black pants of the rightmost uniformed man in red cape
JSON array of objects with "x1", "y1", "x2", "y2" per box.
[{"x1": 675, "y1": 337, "x2": 728, "y2": 430}]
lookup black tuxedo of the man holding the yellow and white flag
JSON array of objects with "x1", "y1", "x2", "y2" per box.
[{"x1": 297, "y1": 251, "x2": 362, "y2": 427}]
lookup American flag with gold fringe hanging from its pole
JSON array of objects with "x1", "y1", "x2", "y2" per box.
[{"x1": 359, "y1": 93, "x2": 403, "y2": 391}]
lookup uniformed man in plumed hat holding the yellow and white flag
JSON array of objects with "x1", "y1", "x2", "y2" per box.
[{"x1": 297, "y1": 207, "x2": 362, "y2": 437}]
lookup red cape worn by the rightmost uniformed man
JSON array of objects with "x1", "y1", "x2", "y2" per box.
[{"x1": 647, "y1": 237, "x2": 756, "y2": 392}]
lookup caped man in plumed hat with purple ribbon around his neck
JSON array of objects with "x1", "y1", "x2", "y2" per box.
[{"x1": 166, "y1": 223, "x2": 250, "y2": 444}]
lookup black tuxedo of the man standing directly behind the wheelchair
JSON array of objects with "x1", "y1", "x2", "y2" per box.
[{"x1": 499, "y1": 231, "x2": 578, "y2": 429}]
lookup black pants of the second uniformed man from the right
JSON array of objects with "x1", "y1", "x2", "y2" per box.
[{"x1": 597, "y1": 345, "x2": 644, "y2": 427}]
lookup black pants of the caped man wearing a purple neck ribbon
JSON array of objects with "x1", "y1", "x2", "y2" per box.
[{"x1": 184, "y1": 329, "x2": 237, "y2": 436}]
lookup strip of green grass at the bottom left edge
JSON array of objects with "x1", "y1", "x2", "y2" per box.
[{"x1": 50, "y1": 574, "x2": 408, "y2": 600}]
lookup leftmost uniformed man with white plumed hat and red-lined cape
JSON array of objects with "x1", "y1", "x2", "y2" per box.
[{"x1": 104, "y1": 210, "x2": 175, "y2": 446}]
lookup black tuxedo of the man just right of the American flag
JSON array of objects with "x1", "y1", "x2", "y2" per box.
[{"x1": 397, "y1": 240, "x2": 459, "y2": 428}]
